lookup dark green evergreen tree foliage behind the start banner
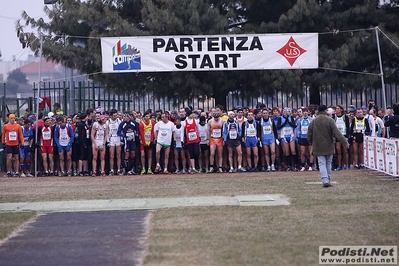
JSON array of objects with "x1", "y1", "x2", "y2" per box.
[{"x1": 17, "y1": 0, "x2": 399, "y2": 105}]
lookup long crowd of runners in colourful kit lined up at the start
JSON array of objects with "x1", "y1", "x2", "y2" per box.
[{"x1": 1, "y1": 100, "x2": 399, "y2": 177}]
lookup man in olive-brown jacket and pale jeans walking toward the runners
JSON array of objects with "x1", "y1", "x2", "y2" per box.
[{"x1": 307, "y1": 105, "x2": 349, "y2": 187}]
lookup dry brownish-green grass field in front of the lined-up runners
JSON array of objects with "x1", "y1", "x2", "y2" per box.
[{"x1": 0, "y1": 170, "x2": 399, "y2": 265}]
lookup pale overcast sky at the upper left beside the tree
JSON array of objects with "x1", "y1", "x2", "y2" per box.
[{"x1": 0, "y1": 0, "x2": 47, "y2": 61}]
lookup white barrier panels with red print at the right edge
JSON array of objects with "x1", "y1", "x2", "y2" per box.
[{"x1": 364, "y1": 136, "x2": 399, "y2": 176}]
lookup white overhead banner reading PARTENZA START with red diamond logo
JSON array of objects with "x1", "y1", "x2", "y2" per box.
[{"x1": 101, "y1": 33, "x2": 319, "y2": 73}]
